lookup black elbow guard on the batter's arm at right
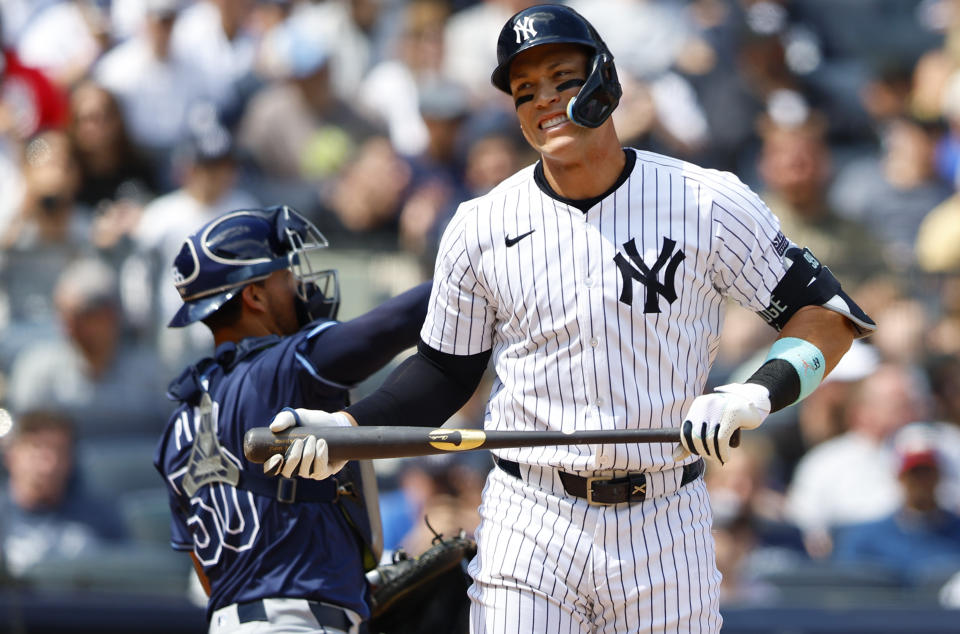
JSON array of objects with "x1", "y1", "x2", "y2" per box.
[{"x1": 757, "y1": 246, "x2": 877, "y2": 338}]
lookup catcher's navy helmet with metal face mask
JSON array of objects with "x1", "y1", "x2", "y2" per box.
[{"x1": 169, "y1": 205, "x2": 340, "y2": 328}]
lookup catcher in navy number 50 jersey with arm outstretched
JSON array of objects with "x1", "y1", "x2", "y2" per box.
[{"x1": 154, "y1": 206, "x2": 429, "y2": 633}]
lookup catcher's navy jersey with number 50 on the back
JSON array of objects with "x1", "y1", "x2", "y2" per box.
[{"x1": 154, "y1": 322, "x2": 369, "y2": 618}]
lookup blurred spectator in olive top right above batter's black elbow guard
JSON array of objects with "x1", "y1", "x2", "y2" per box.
[{"x1": 759, "y1": 108, "x2": 881, "y2": 283}]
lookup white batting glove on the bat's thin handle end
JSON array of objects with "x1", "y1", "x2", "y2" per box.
[{"x1": 673, "y1": 383, "x2": 770, "y2": 465}]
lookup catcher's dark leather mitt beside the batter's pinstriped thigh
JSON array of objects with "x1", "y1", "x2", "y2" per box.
[{"x1": 367, "y1": 531, "x2": 477, "y2": 634}]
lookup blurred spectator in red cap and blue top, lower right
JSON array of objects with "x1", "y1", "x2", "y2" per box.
[{"x1": 834, "y1": 434, "x2": 960, "y2": 584}]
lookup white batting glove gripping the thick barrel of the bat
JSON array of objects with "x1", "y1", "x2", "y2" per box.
[{"x1": 263, "y1": 407, "x2": 352, "y2": 480}]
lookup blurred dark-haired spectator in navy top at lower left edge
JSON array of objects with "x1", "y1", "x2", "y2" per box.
[{"x1": 0, "y1": 410, "x2": 126, "y2": 577}]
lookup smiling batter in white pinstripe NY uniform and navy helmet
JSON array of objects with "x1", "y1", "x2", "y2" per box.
[{"x1": 264, "y1": 5, "x2": 875, "y2": 633}]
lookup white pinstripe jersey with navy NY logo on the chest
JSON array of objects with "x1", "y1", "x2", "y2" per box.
[{"x1": 421, "y1": 149, "x2": 787, "y2": 471}]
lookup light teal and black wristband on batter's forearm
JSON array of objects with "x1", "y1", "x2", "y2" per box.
[{"x1": 746, "y1": 337, "x2": 827, "y2": 411}]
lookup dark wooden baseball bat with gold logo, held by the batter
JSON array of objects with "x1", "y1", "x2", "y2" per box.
[{"x1": 243, "y1": 425, "x2": 680, "y2": 463}]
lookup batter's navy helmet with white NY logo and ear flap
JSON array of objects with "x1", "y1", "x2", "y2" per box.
[{"x1": 490, "y1": 4, "x2": 623, "y2": 128}]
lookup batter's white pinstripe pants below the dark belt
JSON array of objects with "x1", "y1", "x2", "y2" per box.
[{"x1": 469, "y1": 465, "x2": 722, "y2": 634}]
